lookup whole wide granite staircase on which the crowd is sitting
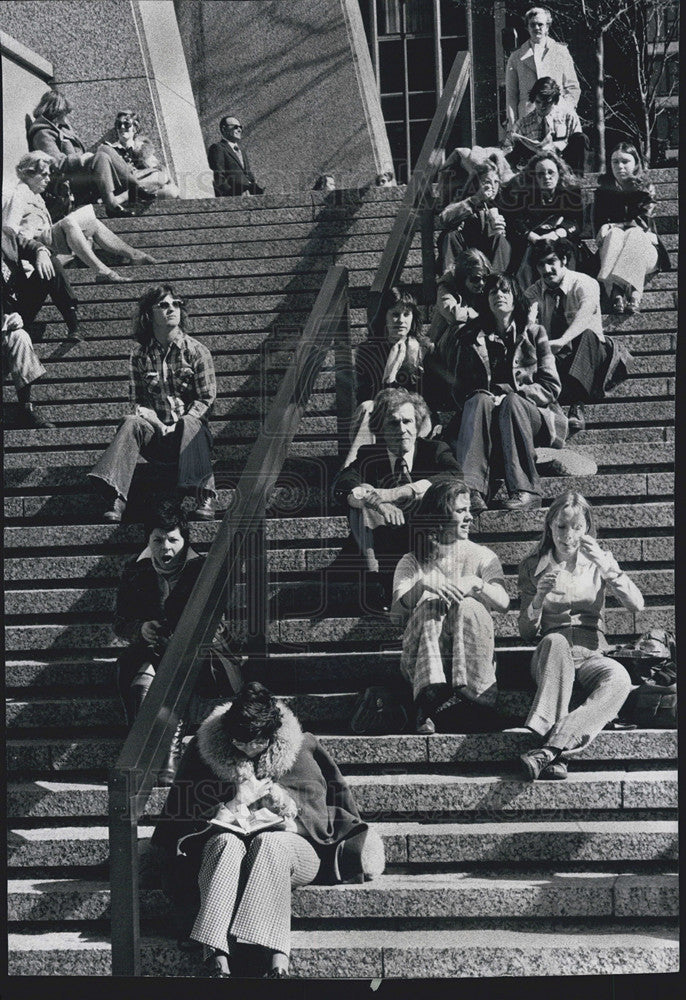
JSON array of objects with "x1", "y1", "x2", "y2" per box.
[{"x1": 4, "y1": 170, "x2": 678, "y2": 978}]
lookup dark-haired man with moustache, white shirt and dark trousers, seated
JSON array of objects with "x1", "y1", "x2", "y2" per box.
[{"x1": 524, "y1": 239, "x2": 619, "y2": 436}]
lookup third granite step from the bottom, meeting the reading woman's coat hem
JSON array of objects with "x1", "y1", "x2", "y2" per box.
[{"x1": 7, "y1": 819, "x2": 678, "y2": 877}]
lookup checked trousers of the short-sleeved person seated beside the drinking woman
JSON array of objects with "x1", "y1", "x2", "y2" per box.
[{"x1": 400, "y1": 597, "x2": 498, "y2": 706}]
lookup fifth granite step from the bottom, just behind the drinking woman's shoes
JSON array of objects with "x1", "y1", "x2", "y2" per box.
[{"x1": 7, "y1": 732, "x2": 677, "y2": 779}]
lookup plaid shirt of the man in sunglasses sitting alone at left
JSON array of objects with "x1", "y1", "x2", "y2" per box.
[{"x1": 129, "y1": 333, "x2": 217, "y2": 424}]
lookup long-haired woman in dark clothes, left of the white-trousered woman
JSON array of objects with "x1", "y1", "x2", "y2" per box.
[{"x1": 501, "y1": 150, "x2": 584, "y2": 291}]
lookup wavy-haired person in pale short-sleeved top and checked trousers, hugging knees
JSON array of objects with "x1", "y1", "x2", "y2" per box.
[{"x1": 391, "y1": 474, "x2": 510, "y2": 733}]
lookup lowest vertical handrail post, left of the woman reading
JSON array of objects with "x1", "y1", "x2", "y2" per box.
[{"x1": 109, "y1": 768, "x2": 141, "y2": 976}]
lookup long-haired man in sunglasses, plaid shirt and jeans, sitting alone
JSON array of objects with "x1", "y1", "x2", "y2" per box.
[{"x1": 88, "y1": 284, "x2": 217, "y2": 523}]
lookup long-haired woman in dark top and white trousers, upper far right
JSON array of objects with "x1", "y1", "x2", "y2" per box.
[{"x1": 593, "y1": 142, "x2": 671, "y2": 314}]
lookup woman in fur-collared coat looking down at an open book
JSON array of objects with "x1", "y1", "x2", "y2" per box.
[{"x1": 153, "y1": 682, "x2": 384, "y2": 978}]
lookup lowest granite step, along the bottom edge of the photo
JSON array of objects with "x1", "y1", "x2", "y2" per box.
[{"x1": 8, "y1": 920, "x2": 679, "y2": 979}]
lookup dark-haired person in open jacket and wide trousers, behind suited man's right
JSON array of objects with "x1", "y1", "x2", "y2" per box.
[{"x1": 443, "y1": 274, "x2": 567, "y2": 514}]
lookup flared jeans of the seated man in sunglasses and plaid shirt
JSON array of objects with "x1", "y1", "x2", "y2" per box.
[{"x1": 88, "y1": 416, "x2": 216, "y2": 500}]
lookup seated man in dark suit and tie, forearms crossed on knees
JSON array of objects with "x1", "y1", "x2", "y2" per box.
[{"x1": 333, "y1": 389, "x2": 460, "y2": 611}]
